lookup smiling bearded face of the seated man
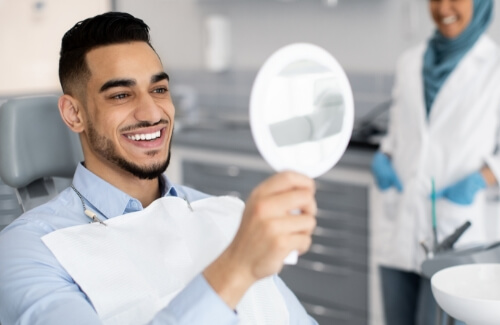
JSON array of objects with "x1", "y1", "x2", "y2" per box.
[{"x1": 83, "y1": 42, "x2": 175, "y2": 179}]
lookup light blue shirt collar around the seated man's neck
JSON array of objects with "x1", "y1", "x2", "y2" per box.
[{"x1": 73, "y1": 164, "x2": 178, "y2": 219}]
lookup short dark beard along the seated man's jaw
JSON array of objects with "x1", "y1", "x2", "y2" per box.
[{"x1": 87, "y1": 122, "x2": 173, "y2": 179}]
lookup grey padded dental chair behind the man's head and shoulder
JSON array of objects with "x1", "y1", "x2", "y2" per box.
[{"x1": 0, "y1": 96, "x2": 83, "y2": 221}]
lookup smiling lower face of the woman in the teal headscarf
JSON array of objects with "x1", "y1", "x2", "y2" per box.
[{"x1": 429, "y1": 0, "x2": 474, "y2": 39}]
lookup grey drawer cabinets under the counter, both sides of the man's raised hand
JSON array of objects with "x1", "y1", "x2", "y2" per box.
[{"x1": 169, "y1": 147, "x2": 370, "y2": 325}]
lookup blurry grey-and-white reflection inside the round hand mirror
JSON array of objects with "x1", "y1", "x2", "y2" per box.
[{"x1": 264, "y1": 61, "x2": 344, "y2": 166}]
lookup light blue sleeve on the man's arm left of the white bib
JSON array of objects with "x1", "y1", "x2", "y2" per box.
[{"x1": 0, "y1": 220, "x2": 101, "y2": 325}]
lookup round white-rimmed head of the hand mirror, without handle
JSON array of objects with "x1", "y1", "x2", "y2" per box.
[{"x1": 250, "y1": 43, "x2": 354, "y2": 177}]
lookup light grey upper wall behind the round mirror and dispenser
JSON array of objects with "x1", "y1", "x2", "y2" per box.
[{"x1": 117, "y1": 0, "x2": 500, "y2": 73}]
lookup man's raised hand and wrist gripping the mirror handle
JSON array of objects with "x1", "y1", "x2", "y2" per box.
[{"x1": 203, "y1": 172, "x2": 317, "y2": 308}]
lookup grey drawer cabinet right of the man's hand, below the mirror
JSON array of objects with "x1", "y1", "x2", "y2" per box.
[{"x1": 280, "y1": 179, "x2": 369, "y2": 325}]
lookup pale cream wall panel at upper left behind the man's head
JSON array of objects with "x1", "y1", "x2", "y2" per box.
[{"x1": 0, "y1": 0, "x2": 111, "y2": 96}]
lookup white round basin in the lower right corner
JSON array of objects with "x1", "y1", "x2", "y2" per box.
[{"x1": 431, "y1": 263, "x2": 500, "y2": 325}]
